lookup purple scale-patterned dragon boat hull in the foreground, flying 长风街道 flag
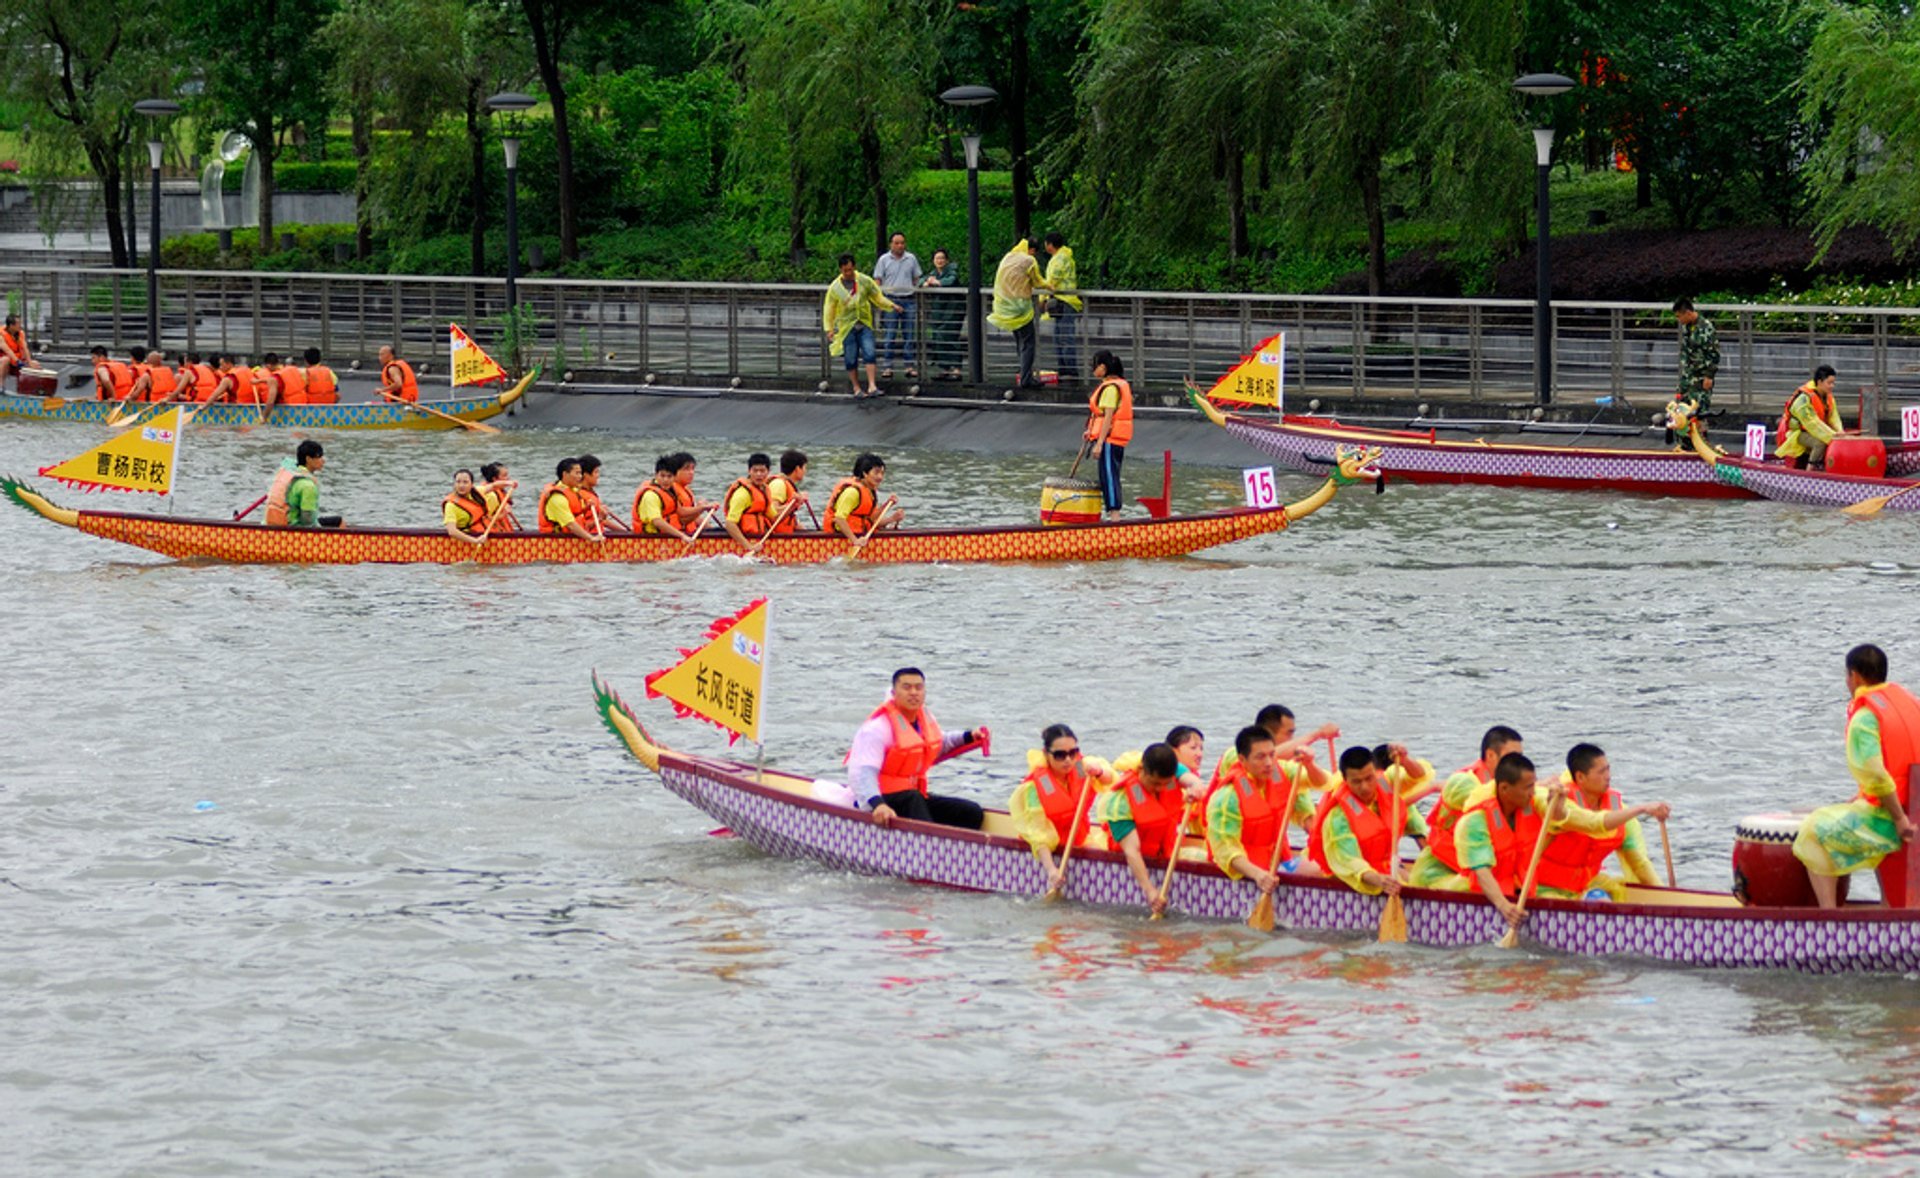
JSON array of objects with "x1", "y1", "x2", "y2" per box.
[{"x1": 593, "y1": 675, "x2": 1920, "y2": 973}]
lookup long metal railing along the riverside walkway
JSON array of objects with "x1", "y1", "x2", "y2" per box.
[{"x1": 15, "y1": 267, "x2": 1920, "y2": 411}]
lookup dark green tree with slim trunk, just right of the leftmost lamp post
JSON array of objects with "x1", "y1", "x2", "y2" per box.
[{"x1": 182, "y1": 0, "x2": 332, "y2": 253}]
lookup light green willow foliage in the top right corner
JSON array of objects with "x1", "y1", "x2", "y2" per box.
[{"x1": 1801, "y1": 4, "x2": 1920, "y2": 253}]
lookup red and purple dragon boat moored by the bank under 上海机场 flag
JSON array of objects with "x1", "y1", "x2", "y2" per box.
[{"x1": 1188, "y1": 389, "x2": 1920, "y2": 499}]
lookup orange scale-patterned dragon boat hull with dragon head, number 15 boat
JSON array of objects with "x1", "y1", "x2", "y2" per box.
[{"x1": 0, "y1": 453, "x2": 1379, "y2": 564}]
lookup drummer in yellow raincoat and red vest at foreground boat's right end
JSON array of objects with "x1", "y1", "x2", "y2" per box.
[{"x1": 1793, "y1": 643, "x2": 1920, "y2": 907}]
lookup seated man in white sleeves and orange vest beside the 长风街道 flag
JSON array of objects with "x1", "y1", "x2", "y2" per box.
[{"x1": 847, "y1": 668, "x2": 991, "y2": 831}]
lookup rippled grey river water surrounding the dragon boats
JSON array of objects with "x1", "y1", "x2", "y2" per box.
[{"x1": 0, "y1": 424, "x2": 1920, "y2": 1174}]
